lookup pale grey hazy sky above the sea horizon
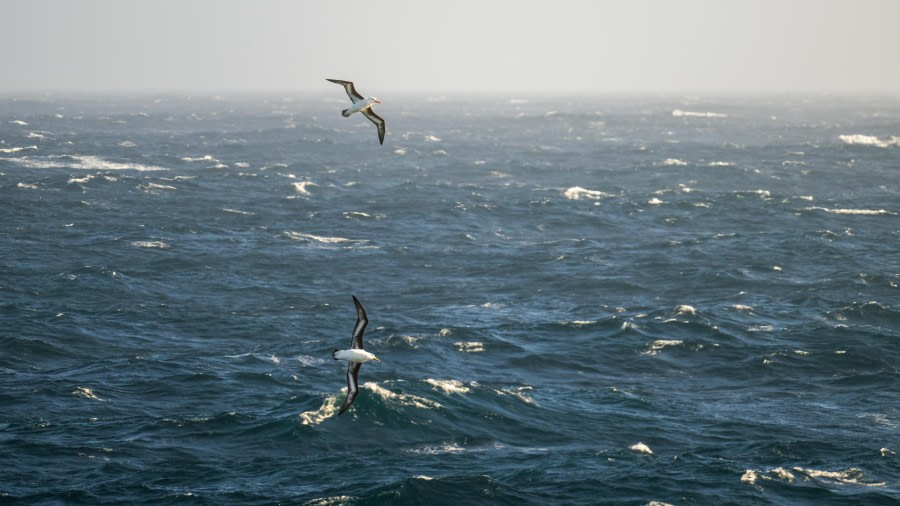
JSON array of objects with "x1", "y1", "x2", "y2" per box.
[{"x1": 0, "y1": 0, "x2": 900, "y2": 96}]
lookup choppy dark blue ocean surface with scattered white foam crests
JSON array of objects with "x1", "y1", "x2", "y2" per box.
[{"x1": 0, "y1": 93, "x2": 900, "y2": 505}]
